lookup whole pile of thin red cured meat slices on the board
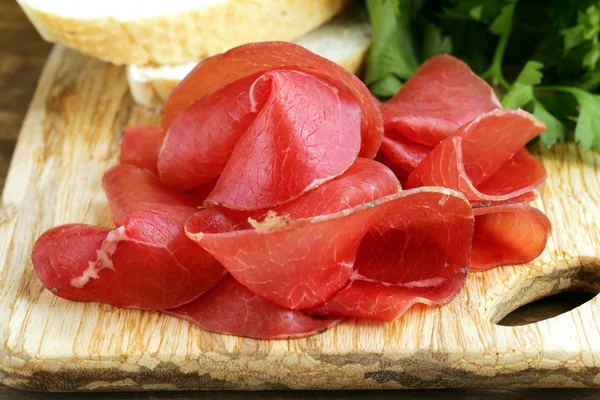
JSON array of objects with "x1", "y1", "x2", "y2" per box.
[{"x1": 33, "y1": 42, "x2": 550, "y2": 339}]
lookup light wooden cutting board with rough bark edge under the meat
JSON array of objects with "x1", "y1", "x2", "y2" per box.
[{"x1": 0, "y1": 47, "x2": 600, "y2": 391}]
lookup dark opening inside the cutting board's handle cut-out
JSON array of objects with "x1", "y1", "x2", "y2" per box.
[{"x1": 496, "y1": 290, "x2": 598, "y2": 326}]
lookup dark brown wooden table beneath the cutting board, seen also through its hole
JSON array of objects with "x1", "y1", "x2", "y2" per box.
[{"x1": 0, "y1": 0, "x2": 600, "y2": 400}]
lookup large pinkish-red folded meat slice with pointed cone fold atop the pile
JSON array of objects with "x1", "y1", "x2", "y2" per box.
[{"x1": 158, "y1": 71, "x2": 361, "y2": 210}]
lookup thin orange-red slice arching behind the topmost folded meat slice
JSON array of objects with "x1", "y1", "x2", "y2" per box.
[{"x1": 162, "y1": 42, "x2": 383, "y2": 158}]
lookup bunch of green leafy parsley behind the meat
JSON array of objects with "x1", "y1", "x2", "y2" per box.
[{"x1": 365, "y1": 0, "x2": 600, "y2": 153}]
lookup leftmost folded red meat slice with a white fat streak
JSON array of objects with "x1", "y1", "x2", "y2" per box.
[{"x1": 32, "y1": 165, "x2": 225, "y2": 310}]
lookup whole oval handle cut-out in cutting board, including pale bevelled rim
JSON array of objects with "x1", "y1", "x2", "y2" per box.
[{"x1": 490, "y1": 257, "x2": 600, "y2": 326}]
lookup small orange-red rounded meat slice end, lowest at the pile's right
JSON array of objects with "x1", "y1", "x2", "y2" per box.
[{"x1": 471, "y1": 204, "x2": 550, "y2": 271}]
